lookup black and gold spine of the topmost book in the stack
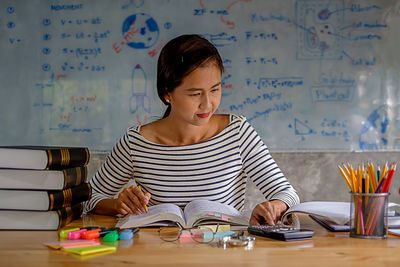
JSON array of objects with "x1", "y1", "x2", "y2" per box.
[{"x1": 46, "y1": 148, "x2": 90, "y2": 170}]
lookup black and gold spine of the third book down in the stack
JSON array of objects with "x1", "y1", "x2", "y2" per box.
[{"x1": 48, "y1": 183, "x2": 92, "y2": 210}]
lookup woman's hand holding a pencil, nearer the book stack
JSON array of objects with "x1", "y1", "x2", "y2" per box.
[{"x1": 114, "y1": 185, "x2": 151, "y2": 215}]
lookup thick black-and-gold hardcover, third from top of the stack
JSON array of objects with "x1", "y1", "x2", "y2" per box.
[{"x1": 0, "y1": 183, "x2": 92, "y2": 211}]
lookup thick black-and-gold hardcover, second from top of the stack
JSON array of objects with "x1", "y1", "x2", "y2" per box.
[{"x1": 0, "y1": 166, "x2": 87, "y2": 190}]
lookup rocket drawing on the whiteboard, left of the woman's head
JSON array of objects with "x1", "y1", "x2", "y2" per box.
[{"x1": 129, "y1": 64, "x2": 150, "y2": 114}]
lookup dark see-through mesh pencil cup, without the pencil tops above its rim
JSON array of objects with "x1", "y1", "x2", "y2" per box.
[{"x1": 350, "y1": 193, "x2": 389, "y2": 238}]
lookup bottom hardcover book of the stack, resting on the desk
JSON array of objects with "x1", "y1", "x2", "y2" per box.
[{"x1": 0, "y1": 203, "x2": 82, "y2": 230}]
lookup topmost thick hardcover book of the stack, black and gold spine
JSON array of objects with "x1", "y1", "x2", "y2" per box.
[{"x1": 0, "y1": 146, "x2": 90, "y2": 170}]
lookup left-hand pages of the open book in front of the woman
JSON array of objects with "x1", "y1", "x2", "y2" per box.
[{"x1": 116, "y1": 204, "x2": 185, "y2": 228}]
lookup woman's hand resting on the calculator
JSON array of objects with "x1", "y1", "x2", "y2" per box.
[{"x1": 250, "y1": 200, "x2": 288, "y2": 225}]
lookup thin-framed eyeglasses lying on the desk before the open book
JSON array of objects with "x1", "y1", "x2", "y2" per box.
[{"x1": 158, "y1": 224, "x2": 219, "y2": 243}]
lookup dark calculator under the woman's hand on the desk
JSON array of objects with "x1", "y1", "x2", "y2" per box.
[{"x1": 247, "y1": 225, "x2": 314, "y2": 241}]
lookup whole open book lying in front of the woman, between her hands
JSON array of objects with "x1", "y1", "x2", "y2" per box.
[{"x1": 116, "y1": 199, "x2": 249, "y2": 228}]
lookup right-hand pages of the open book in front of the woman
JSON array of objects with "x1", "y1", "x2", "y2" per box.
[{"x1": 184, "y1": 199, "x2": 249, "y2": 227}]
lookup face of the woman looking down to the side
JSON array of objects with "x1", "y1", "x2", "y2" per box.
[{"x1": 166, "y1": 63, "x2": 221, "y2": 126}]
